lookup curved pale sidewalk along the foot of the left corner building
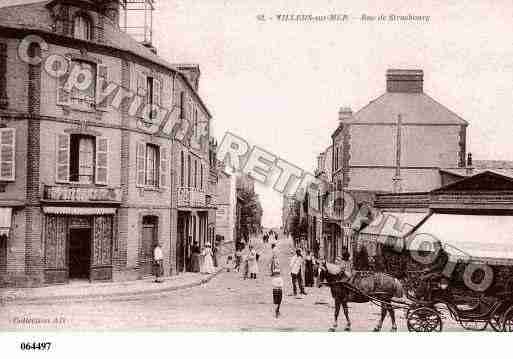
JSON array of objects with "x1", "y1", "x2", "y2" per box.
[{"x1": 0, "y1": 267, "x2": 225, "y2": 305}]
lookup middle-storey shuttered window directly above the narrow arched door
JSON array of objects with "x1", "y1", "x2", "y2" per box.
[{"x1": 136, "y1": 142, "x2": 168, "y2": 188}]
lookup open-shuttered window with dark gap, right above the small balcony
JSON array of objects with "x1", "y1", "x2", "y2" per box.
[{"x1": 55, "y1": 133, "x2": 109, "y2": 185}]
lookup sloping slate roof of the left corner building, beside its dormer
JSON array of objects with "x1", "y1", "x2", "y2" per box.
[{"x1": 0, "y1": 0, "x2": 211, "y2": 116}]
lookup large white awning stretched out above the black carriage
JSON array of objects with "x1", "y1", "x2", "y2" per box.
[{"x1": 410, "y1": 213, "x2": 513, "y2": 265}]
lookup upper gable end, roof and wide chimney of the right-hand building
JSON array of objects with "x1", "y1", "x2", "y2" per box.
[{"x1": 332, "y1": 69, "x2": 468, "y2": 192}]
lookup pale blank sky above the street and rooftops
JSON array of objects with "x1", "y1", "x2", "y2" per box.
[{"x1": 4, "y1": 0, "x2": 513, "y2": 226}]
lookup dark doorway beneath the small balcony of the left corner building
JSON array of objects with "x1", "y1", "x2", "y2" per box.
[{"x1": 68, "y1": 228, "x2": 91, "y2": 279}]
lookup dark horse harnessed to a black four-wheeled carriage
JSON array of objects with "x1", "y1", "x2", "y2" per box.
[{"x1": 320, "y1": 265, "x2": 513, "y2": 332}]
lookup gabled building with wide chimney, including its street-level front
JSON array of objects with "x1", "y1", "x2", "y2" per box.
[{"x1": 310, "y1": 69, "x2": 468, "y2": 261}]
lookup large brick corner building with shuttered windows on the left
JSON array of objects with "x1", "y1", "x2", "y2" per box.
[{"x1": 0, "y1": 0, "x2": 215, "y2": 286}]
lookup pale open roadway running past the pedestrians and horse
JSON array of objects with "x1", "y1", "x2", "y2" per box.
[{"x1": 0, "y1": 239, "x2": 464, "y2": 331}]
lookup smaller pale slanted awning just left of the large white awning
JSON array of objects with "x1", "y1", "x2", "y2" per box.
[{"x1": 360, "y1": 212, "x2": 428, "y2": 238}]
